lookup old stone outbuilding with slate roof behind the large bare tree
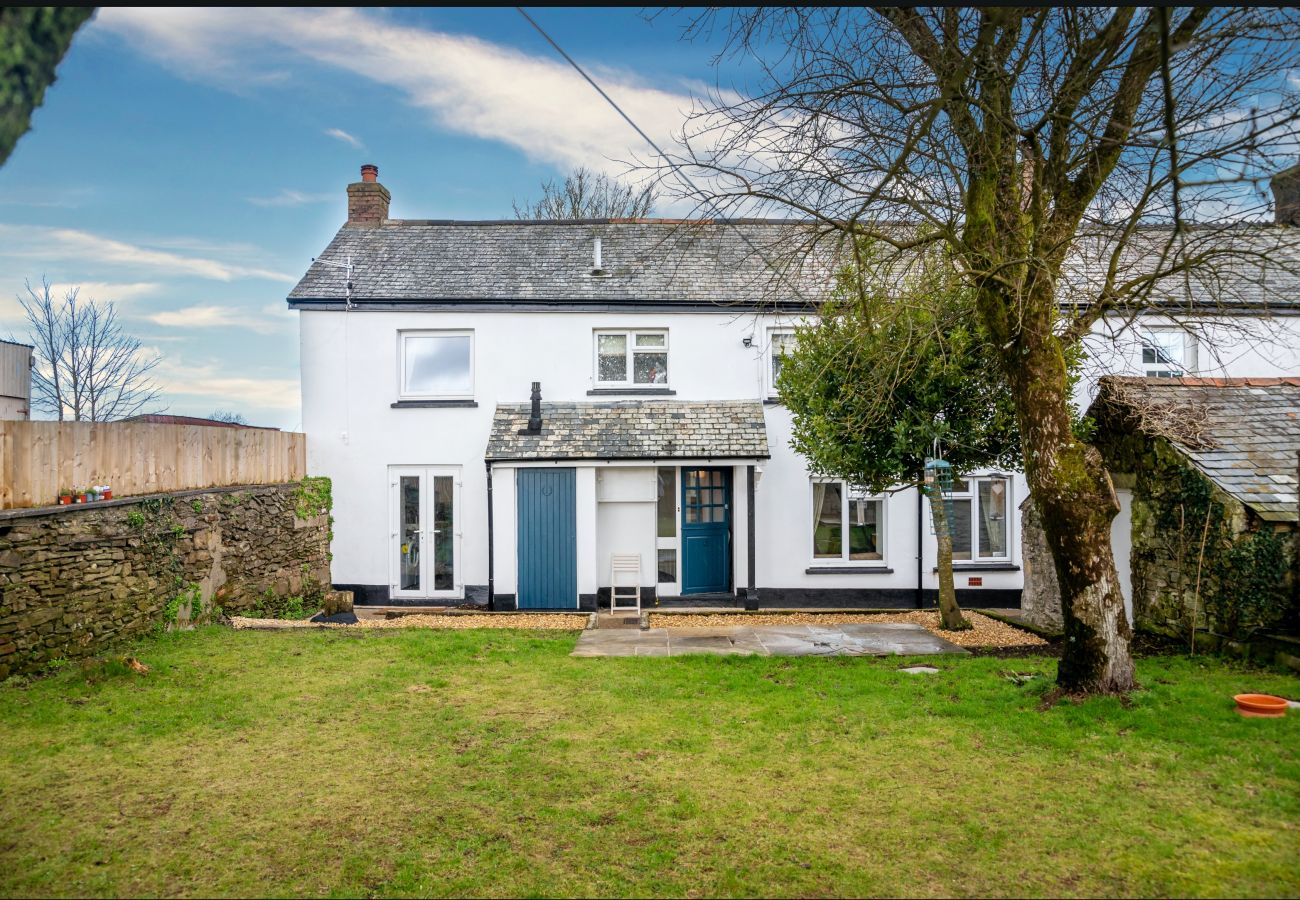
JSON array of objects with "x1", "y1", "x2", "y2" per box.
[{"x1": 1089, "y1": 377, "x2": 1300, "y2": 637}]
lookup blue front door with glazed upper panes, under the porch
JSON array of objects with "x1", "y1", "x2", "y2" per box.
[{"x1": 681, "y1": 468, "x2": 731, "y2": 594}]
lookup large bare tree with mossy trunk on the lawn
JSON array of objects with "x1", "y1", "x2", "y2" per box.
[{"x1": 670, "y1": 7, "x2": 1300, "y2": 692}]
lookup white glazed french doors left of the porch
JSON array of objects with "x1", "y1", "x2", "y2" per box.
[{"x1": 389, "y1": 466, "x2": 464, "y2": 600}]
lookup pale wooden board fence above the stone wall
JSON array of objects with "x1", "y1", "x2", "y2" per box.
[{"x1": 0, "y1": 421, "x2": 307, "y2": 510}]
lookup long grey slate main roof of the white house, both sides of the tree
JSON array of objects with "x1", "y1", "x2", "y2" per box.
[{"x1": 289, "y1": 218, "x2": 1300, "y2": 312}]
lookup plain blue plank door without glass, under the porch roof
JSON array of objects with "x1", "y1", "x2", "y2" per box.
[{"x1": 515, "y1": 468, "x2": 577, "y2": 610}]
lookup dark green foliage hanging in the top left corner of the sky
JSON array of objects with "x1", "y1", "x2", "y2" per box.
[{"x1": 0, "y1": 7, "x2": 95, "y2": 165}]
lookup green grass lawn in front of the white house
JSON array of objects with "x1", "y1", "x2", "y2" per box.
[{"x1": 0, "y1": 627, "x2": 1300, "y2": 896}]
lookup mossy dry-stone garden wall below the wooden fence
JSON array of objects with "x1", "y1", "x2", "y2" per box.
[{"x1": 0, "y1": 483, "x2": 329, "y2": 679}]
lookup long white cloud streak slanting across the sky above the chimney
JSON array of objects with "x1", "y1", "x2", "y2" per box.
[{"x1": 92, "y1": 8, "x2": 692, "y2": 172}]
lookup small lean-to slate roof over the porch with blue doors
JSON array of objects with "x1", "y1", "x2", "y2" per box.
[{"x1": 488, "y1": 399, "x2": 770, "y2": 460}]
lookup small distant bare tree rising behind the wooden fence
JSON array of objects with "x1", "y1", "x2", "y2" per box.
[{"x1": 18, "y1": 278, "x2": 161, "y2": 421}]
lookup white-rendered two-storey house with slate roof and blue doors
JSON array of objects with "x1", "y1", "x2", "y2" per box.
[{"x1": 289, "y1": 166, "x2": 1300, "y2": 609}]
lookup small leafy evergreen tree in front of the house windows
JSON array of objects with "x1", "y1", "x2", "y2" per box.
[{"x1": 776, "y1": 250, "x2": 1021, "y2": 631}]
